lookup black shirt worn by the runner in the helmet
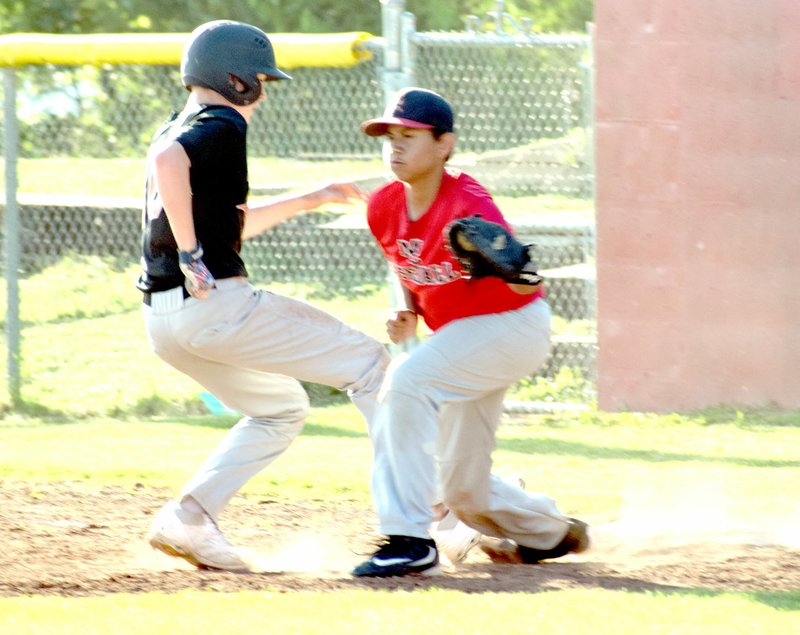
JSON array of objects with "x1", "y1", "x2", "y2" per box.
[{"x1": 136, "y1": 105, "x2": 249, "y2": 292}]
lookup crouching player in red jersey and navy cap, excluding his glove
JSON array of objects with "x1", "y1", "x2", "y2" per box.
[{"x1": 353, "y1": 88, "x2": 589, "y2": 576}]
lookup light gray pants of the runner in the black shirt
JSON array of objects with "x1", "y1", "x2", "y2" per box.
[{"x1": 143, "y1": 278, "x2": 390, "y2": 520}]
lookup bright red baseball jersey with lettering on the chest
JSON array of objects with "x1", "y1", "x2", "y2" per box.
[{"x1": 367, "y1": 169, "x2": 542, "y2": 331}]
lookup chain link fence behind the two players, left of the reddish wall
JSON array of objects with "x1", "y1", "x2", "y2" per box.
[{"x1": 2, "y1": 16, "x2": 594, "y2": 415}]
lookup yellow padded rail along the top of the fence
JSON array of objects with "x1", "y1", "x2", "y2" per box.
[{"x1": 0, "y1": 32, "x2": 373, "y2": 68}]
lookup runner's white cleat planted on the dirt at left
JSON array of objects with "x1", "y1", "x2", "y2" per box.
[{"x1": 148, "y1": 501, "x2": 250, "y2": 571}]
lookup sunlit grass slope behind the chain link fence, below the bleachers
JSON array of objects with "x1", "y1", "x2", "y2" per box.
[{"x1": 0, "y1": 255, "x2": 591, "y2": 418}]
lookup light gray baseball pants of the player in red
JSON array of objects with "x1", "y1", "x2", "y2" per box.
[{"x1": 372, "y1": 300, "x2": 568, "y2": 549}]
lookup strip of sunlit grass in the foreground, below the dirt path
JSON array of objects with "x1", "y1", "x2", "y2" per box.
[{"x1": 0, "y1": 589, "x2": 800, "y2": 635}]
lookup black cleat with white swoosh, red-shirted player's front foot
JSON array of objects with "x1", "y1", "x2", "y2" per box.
[{"x1": 351, "y1": 536, "x2": 439, "y2": 578}]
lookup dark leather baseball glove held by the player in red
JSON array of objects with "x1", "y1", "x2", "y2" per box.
[{"x1": 445, "y1": 215, "x2": 542, "y2": 285}]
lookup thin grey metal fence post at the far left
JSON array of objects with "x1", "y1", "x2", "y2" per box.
[{"x1": 3, "y1": 67, "x2": 21, "y2": 407}]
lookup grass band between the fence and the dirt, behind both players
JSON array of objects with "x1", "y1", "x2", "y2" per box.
[{"x1": 0, "y1": 404, "x2": 800, "y2": 522}]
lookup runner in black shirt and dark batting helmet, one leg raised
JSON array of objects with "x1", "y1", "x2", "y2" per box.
[{"x1": 138, "y1": 20, "x2": 389, "y2": 570}]
